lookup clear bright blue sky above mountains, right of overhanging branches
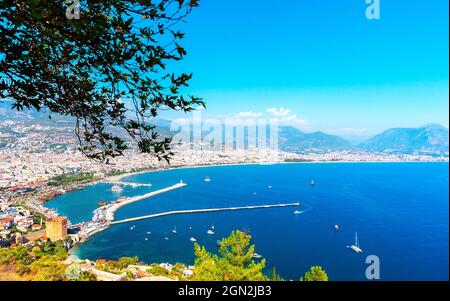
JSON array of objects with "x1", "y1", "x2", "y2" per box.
[{"x1": 163, "y1": 0, "x2": 449, "y2": 139}]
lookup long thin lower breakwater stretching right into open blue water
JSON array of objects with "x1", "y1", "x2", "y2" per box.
[{"x1": 110, "y1": 203, "x2": 300, "y2": 225}]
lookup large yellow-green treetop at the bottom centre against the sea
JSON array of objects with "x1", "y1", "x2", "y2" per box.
[{"x1": 193, "y1": 231, "x2": 268, "y2": 281}]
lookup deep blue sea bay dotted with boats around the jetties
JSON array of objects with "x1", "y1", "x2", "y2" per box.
[{"x1": 47, "y1": 163, "x2": 449, "y2": 280}]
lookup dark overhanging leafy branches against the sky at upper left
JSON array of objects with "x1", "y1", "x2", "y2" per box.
[{"x1": 0, "y1": 0, "x2": 205, "y2": 161}]
